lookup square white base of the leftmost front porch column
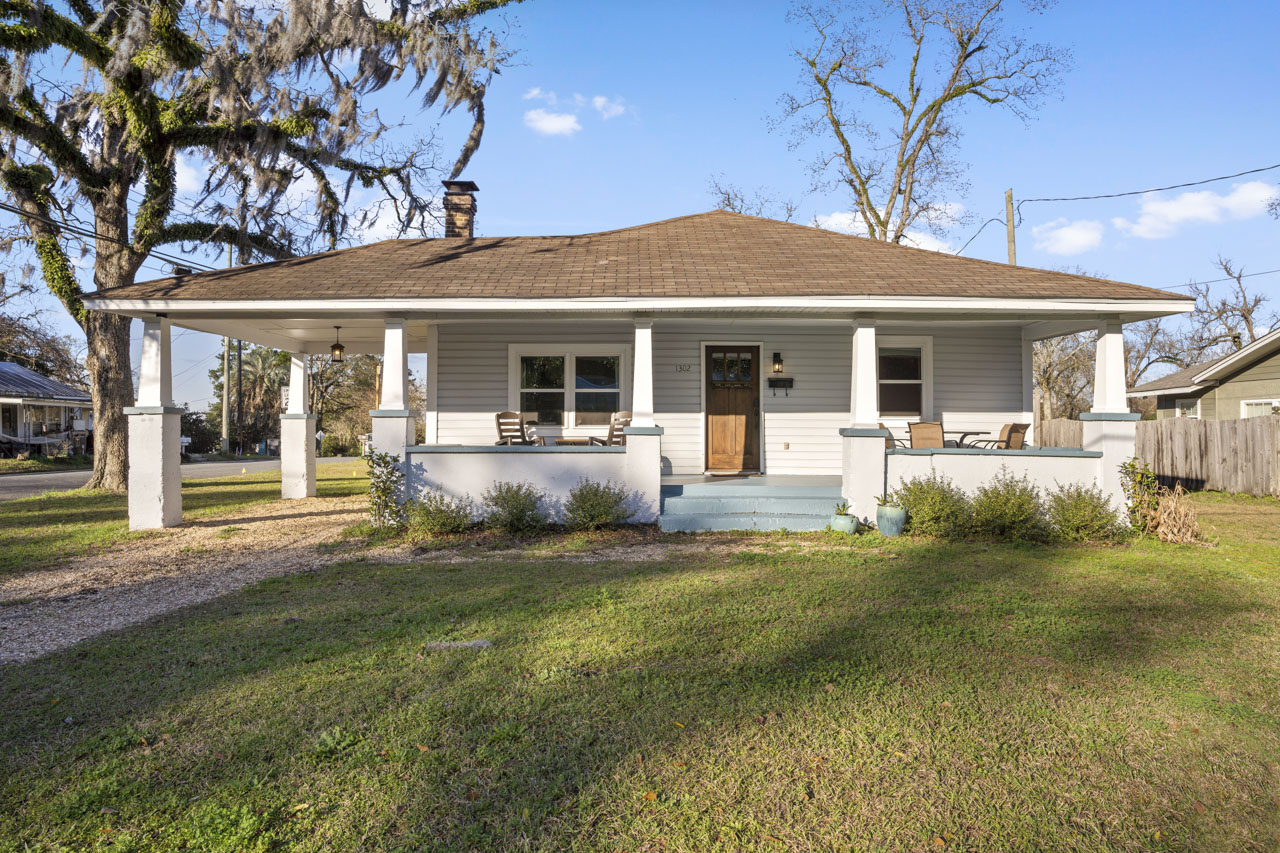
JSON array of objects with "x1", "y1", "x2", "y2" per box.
[{"x1": 124, "y1": 406, "x2": 182, "y2": 530}]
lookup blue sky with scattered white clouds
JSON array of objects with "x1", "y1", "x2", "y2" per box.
[{"x1": 10, "y1": 0, "x2": 1280, "y2": 410}]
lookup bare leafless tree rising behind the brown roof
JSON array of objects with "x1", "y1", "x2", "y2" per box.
[{"x1": 781, "y1": 0, "x2": 1068, "y2": 242}]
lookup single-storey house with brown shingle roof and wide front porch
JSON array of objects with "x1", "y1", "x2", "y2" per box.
[{"x1": 84, "y1": 181, "x2": 1192, "y2": 529}]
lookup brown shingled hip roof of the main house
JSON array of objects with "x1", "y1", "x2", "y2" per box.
[{"x1": 88, "y1": 210, "x2": 1185, "y2": 307}]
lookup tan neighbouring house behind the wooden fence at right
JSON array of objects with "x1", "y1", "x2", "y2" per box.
[{"x1": 1129, "y1": 329, "x2": 1280, "y2": 420}]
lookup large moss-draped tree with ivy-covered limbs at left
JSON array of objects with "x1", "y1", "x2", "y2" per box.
[{"x1": 0, "y1": 0, "x2": 509, "y2": 489}]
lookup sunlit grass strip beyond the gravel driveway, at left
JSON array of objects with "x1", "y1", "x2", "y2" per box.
[{"x1": 0, "y1": 461, "x2": 369, "y2": 576}]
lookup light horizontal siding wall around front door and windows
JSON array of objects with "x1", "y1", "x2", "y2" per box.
[{"x1": 434, "y1": 316, "x2": 1029, "y2": 474}]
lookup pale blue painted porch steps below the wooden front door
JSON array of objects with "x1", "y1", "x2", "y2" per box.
[{"x1": 658, "y1": 474, "x2": 842, "y2": 532}]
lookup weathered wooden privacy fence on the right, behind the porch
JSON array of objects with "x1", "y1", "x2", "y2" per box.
[{"x1": 1036, "y1": 415, "x2": 1280, "y2": 497}]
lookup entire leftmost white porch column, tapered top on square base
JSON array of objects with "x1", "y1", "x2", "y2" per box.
[{"x1": 124, "y1": 316, "x2": 182, "y2": 530}]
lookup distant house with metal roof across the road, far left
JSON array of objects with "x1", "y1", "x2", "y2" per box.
[{"x1": 0, "y1": 361, "x2": 91, "y2": 455}]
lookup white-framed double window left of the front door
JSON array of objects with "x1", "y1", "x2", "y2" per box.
[{"x1": 507, "y1": 343, "x2": 630, "y2": 432}]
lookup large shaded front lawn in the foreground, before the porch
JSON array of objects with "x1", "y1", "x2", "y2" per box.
[{"x1": 0, "y1": 489, "x2": 1280, "y2": 850}]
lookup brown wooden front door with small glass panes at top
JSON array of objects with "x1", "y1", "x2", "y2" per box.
[{"x1": 705, "y1": 345, "x2": 760, "y2": 473}]
